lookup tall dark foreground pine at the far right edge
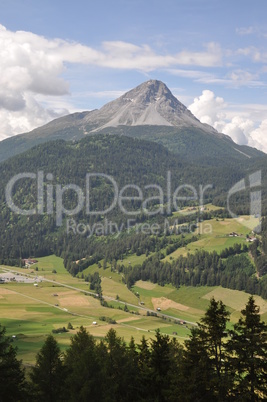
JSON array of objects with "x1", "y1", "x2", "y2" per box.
[{"x1": 228, "y1": 296, "x2": 267, "y2": 402}]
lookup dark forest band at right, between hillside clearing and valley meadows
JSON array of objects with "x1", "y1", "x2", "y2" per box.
[{"x1": 123, "y1": 245, "x2": 267, "y2": 299}]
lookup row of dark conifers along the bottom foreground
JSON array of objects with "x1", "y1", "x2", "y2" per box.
[{"x1": 0, "y1": 296, "x2": 267, "y2": 402}]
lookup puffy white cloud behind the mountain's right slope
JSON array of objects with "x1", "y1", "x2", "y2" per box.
[{"x1": 189, "y1": 90, "x2": 267, "y2": 153}]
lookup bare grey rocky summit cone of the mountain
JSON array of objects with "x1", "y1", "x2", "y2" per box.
[{"x1": 83, "y1": 80, "x2": 220, "y2": 134}]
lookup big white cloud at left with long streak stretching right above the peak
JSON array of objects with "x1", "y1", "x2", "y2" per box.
[{"x1": 0, "y1": 25, "x2": 222, "y2": 140}]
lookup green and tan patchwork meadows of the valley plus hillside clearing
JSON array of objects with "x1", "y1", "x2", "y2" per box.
[{"x1": 0, "y1": 226, "x2": 267, "y2": 364}]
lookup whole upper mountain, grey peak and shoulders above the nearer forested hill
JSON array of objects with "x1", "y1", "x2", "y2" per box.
[{"x1": 0, "y1": 80, "x2": 264, "y2": 166}]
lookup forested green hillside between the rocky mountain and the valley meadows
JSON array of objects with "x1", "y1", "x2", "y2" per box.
[{"x1": 0, "y1": 134, "x2": 266, "y2": 297}]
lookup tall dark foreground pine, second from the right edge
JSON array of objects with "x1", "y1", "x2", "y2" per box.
[{"x1": 182, "y1": 298, "x2": 231, "y2": 402}]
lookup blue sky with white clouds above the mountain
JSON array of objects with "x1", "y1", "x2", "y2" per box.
[{"x1": 0, "y1": 0, "x2": 267, "y2": 152}]
